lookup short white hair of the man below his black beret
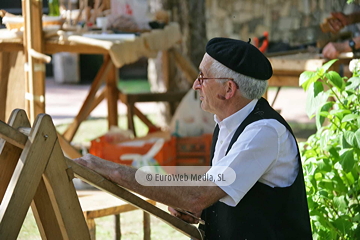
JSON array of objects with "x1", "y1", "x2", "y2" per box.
[{"x1": 208, "y1": 59, "x2": 268, "y2": 100}]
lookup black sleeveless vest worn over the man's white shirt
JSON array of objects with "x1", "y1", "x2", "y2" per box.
[{"x1": 199, "y1": 98, "x2": 312, "y2": 240}]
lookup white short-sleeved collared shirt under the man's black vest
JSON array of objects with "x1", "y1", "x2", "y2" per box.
[{"x1": 209, "y1": 99, "x2": 299, "y2": 206}]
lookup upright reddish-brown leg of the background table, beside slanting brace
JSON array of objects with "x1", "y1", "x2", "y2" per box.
[{"x1": 106, "y1": 59, "x2": 119, "y2": 129}]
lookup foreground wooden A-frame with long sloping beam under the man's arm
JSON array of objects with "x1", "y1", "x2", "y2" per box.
[{"x1": 0, "y1": 110, "x2": 202, "y2": 239}]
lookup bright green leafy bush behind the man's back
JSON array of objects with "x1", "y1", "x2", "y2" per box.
[{"x1": 299, "y1": 60, "x2": 360, "y2": 240}]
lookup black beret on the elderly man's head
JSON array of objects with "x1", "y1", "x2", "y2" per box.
[{"x1": 206, "y1": 38, "x2": 272, "y2": 80}]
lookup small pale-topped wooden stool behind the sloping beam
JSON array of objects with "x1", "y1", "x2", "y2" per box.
[{"x1": 78, "y1": 191, "x2": 156, "y2": 240}]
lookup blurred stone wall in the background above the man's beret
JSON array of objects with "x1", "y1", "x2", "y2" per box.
[{"x1": 206, "y1": 0, "x2": 356, "y2": 49}]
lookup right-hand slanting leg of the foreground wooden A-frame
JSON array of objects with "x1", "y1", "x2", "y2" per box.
[{"x1": 41, "y1": 140, "x2": 90, "y2": 239}]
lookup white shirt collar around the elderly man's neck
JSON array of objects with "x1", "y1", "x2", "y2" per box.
[{"x1": 214, "y1": 99, "x2": 258, "y2": 131}]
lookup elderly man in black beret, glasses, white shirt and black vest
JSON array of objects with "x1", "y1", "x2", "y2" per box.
[{"x1": 75, "y1": 38, "x2": 312, "y2": 240}]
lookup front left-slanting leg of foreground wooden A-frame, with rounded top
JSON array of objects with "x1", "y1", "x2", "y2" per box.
[{"x1": 0, "y1": 115, "x2": 56, "y2": 239}]
